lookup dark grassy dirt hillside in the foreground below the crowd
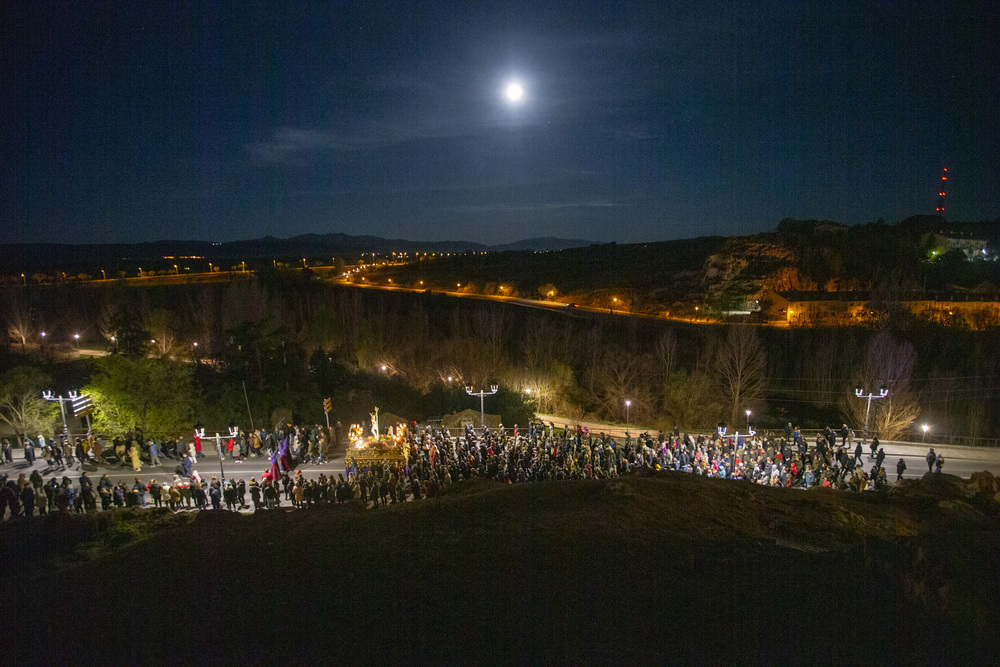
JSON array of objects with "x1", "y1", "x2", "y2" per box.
[{"x1": 0, "y1": 473, "x2": 1000, "y2": 664}]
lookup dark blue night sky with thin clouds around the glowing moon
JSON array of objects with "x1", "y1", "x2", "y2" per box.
[{"x1": 0, "y1": 0, "x2": 1000, "y2": 243}]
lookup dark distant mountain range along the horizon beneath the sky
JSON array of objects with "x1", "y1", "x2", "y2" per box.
[{"x1": 0, "y1": 234, "x2": 591, "y2": 275}]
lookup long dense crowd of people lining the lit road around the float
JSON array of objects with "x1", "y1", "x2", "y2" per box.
[{"x1": 0, "y1": 422, "x2": 944, "y2": 518}]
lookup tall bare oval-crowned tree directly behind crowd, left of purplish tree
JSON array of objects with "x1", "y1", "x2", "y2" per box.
[{"x1": 716, "y1": 324, "x2": 767, "y2": 424}]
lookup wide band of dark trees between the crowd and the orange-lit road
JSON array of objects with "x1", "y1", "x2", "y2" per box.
[{"x1": 0, "y1": 272, "x2": 1000, "y2": 438}]
